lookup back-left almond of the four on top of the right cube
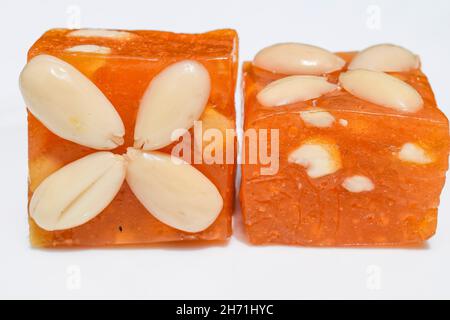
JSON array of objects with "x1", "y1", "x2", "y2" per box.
[{"x1": 253, "y1": 43, "x2": 345, "y2": 75}]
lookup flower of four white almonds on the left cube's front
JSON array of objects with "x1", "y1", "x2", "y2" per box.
[{"x1": 20, "y1": 55, "x2": 223, "y2": 232}]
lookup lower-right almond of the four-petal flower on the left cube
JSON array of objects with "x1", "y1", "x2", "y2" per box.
[{"x1": 126, "y1": 148, "x2": 223, "y2": 232}]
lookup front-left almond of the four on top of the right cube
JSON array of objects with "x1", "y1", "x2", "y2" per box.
[{"x1": 256, "y1": 76, "x2": 338, "y2": 107}]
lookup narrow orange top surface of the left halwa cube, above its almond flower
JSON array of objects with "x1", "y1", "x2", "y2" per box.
[{"x1": 30, "y1": 29, "x2": 237, "y2": 60}]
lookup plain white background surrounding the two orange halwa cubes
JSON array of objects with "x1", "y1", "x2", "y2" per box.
[{"x1": 0, "y1": 0, "x2": 450, "y2": 299}]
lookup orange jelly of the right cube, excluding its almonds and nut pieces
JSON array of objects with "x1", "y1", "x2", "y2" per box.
[{"x1": 240, "y1": 52, "x2": 449, "y2": 246}]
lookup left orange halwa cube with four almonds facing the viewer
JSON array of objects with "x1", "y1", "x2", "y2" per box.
[{"x1": 19, "y1": 29, "x2": 237, "y2": 247}]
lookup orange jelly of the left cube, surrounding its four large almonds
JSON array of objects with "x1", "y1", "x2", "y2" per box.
[{"x1": 28, "y1": 29, "x2": 238, "y2": 247}]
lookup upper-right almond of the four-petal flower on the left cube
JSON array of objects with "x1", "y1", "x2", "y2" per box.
[{"x1": 134, "y1": 60, "x2": 211, "y2": 150}]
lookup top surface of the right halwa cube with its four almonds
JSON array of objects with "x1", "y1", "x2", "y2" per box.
[{"x1": 244, "y1": 43, "x2": 448, "y2": 126}]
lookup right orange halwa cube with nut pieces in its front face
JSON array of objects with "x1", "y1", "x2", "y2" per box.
[{"x1": 241, "y1": 43, "x2": 449, "y2": 246}]
